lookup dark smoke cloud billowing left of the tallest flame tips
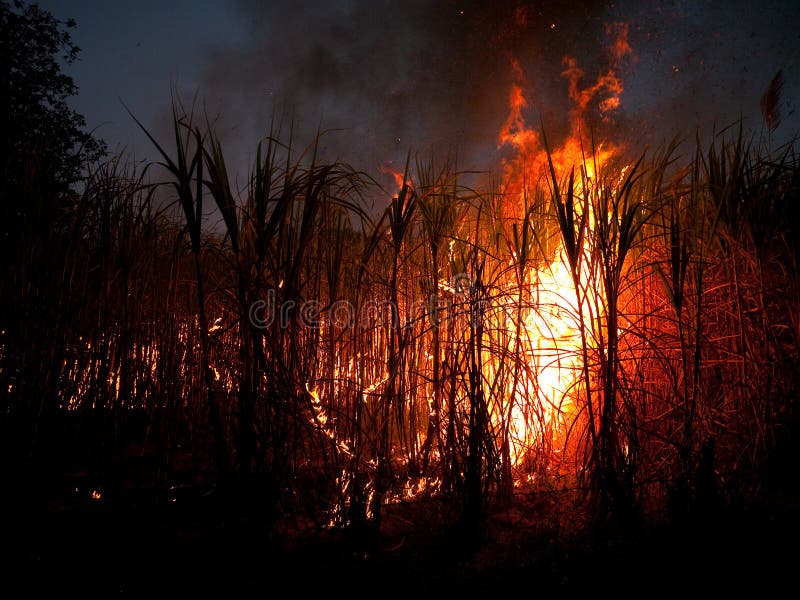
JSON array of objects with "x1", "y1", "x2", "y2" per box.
[{"x1": 192, "y1": 0, "x2": 607, "y2": 178}]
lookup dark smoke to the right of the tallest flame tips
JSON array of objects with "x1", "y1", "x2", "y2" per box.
[{"x1": 614, "y1": 0, "x2": 800, "y2": 145}]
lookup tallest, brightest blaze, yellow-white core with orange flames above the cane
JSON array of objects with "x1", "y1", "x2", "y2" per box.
[{"x1": 497, "y1": 24, "x2": 631, "y2": 474}]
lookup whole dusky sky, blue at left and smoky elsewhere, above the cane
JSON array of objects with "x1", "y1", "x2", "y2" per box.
[{"x1": 41, "y1": 0, "x2": 800, "y2": 188}]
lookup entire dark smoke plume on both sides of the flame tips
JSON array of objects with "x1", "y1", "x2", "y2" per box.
[{"x1": 184, "y1": 0, "x2": 800, "y2": 183}]
